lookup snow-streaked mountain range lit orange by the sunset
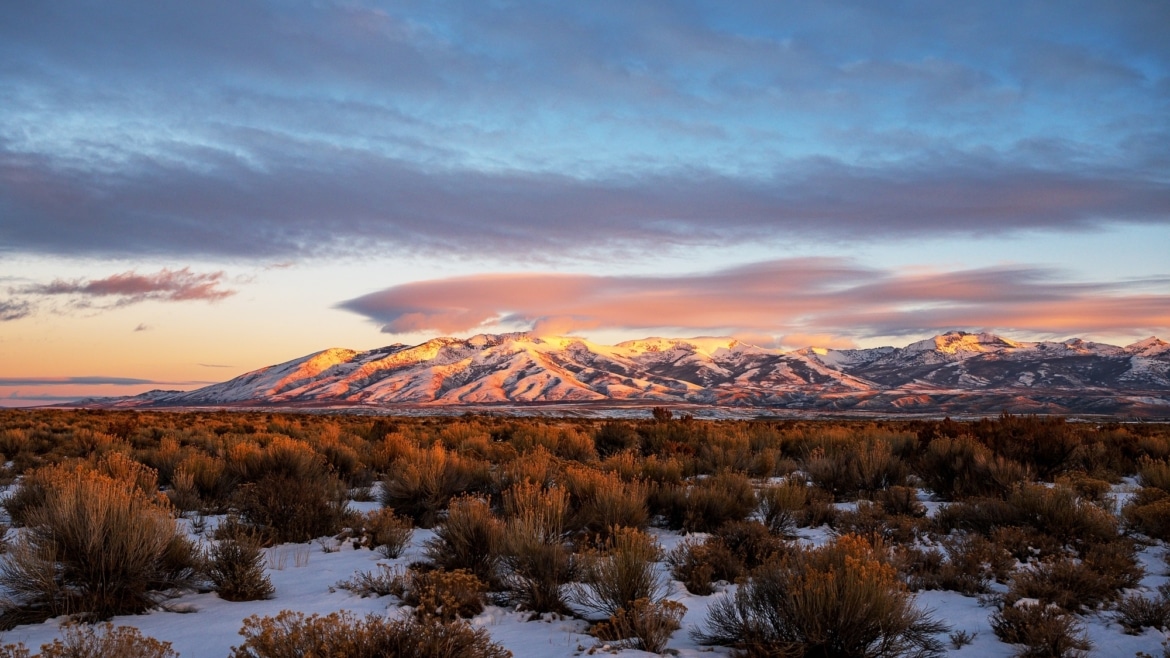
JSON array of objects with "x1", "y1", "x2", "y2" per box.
[{"x1": 111, "y1": 331, "x2": 1170, "y2": 417}]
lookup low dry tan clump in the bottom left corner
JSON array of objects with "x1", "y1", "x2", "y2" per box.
[{"x1": 0, "y1": 624, "x2": 179, "y2": 658}]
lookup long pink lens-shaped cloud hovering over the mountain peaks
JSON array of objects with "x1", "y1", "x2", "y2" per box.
[{"x1": 339, "y1": 259, "x2": 1170, "y2": 337}]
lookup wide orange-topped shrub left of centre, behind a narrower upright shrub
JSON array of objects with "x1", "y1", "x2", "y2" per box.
[{"x1": 381, "y1": 444, "x2": 489, "y2": 528}]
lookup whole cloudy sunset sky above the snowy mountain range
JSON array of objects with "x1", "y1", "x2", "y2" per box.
[{"x1": 0, "y1": 0, "x2": 1170, "y2": 405}]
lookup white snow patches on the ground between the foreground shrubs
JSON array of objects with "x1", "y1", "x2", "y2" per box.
[{"x1": 0, "y1": 491, "x2": 1170, "y2": 658}]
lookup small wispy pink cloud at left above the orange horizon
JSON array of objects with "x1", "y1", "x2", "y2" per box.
[{"x1": 35, "y1": 267, "x2": 235, "y2": 306}]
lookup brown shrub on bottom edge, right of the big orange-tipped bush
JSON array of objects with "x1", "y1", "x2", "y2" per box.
[{"x1": 991, "y1": 601, "x2": 1093, "y2": 658}]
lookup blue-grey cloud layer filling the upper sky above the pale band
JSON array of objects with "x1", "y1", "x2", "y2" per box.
[{"x1": 0, "y1": 0, "x2": 1170, "y2": 258}]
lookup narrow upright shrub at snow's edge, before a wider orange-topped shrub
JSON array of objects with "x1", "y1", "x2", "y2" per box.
[{"x1": 425, "y1": 498, "x2": 503, "y2": 587}]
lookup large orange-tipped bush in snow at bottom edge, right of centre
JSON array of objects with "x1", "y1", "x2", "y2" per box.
[{"x1": 696, "y1": 536, "x2": 945, "y2": 658}]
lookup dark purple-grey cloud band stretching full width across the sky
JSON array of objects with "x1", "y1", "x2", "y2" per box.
[{"x1": 0, "y1": 137, "x2": 1170, "y2": 257}]
